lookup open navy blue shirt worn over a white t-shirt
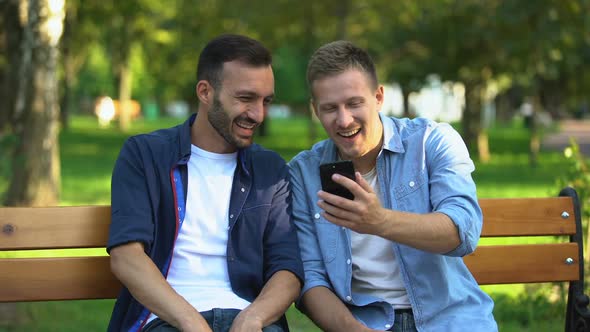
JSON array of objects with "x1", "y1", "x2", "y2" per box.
[{"x1": 107, "y1": 115, "x2": 303, "y2": 331}]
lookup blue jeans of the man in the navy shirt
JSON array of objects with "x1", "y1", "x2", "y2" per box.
[{"x1": 142, "y1": 308, "x2": 284, "y2": 332}]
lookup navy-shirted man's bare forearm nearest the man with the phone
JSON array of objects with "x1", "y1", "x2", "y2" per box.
[{"x1": 230, "y1": 270, "x2": 301, "y2": 332}]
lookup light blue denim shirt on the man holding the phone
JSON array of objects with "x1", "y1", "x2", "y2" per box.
[{"x1": 289, "y1": 115, "x2": 498, "y2": 332}]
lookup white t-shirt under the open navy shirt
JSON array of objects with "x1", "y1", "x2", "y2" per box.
[{"x1": 148, "y1": 145, "x2": 250, "y2": 322}]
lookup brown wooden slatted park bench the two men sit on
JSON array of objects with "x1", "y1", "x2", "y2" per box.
[{"x1": 0, "y1": 188, "x2": 590, "y2": 331}]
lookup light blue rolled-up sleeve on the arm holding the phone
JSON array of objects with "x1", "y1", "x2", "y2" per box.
[{"x1": 426, "y1": 124, "x2": 483, "y2": 257}]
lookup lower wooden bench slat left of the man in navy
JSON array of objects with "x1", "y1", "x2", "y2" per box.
[{"x1": 0, "y1": 256, "x2": 121, "y2": 302}]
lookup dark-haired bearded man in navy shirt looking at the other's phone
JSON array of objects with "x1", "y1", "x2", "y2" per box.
[{"x1": 107, "y1": 35, "x2": 303, "y2": 332}]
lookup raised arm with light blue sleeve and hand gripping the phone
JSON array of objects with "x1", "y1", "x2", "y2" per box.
[{"x1": 318, "y1": 124, "x2": 482, "y2": 256}]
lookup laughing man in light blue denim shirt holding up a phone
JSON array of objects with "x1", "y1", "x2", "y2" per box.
[{"x1": 289, "y1": 41, "x2": 498, "y2": 332}]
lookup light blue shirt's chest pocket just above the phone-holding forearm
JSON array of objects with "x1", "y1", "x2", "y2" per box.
[{"x1": 394, "y1": 169, "x2": 430, "y2": 213}]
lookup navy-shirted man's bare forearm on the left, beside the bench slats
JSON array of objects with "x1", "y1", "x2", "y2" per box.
[{"x1": 110, "y1": 242, "x2": 211, "y2": 331}]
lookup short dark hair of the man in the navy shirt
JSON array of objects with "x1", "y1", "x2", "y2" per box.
[{"x1": 197, "y1": 34, "x2": 272, "y2": 88}]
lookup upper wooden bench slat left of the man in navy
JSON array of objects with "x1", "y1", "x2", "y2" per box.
[{"x1": 0, "y1": 206, "x2": 111, "y2": 250}]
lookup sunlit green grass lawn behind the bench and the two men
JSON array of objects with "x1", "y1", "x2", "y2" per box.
[{"x1": 0, "y1": 116, "x2": 584, "y2": 331}]
